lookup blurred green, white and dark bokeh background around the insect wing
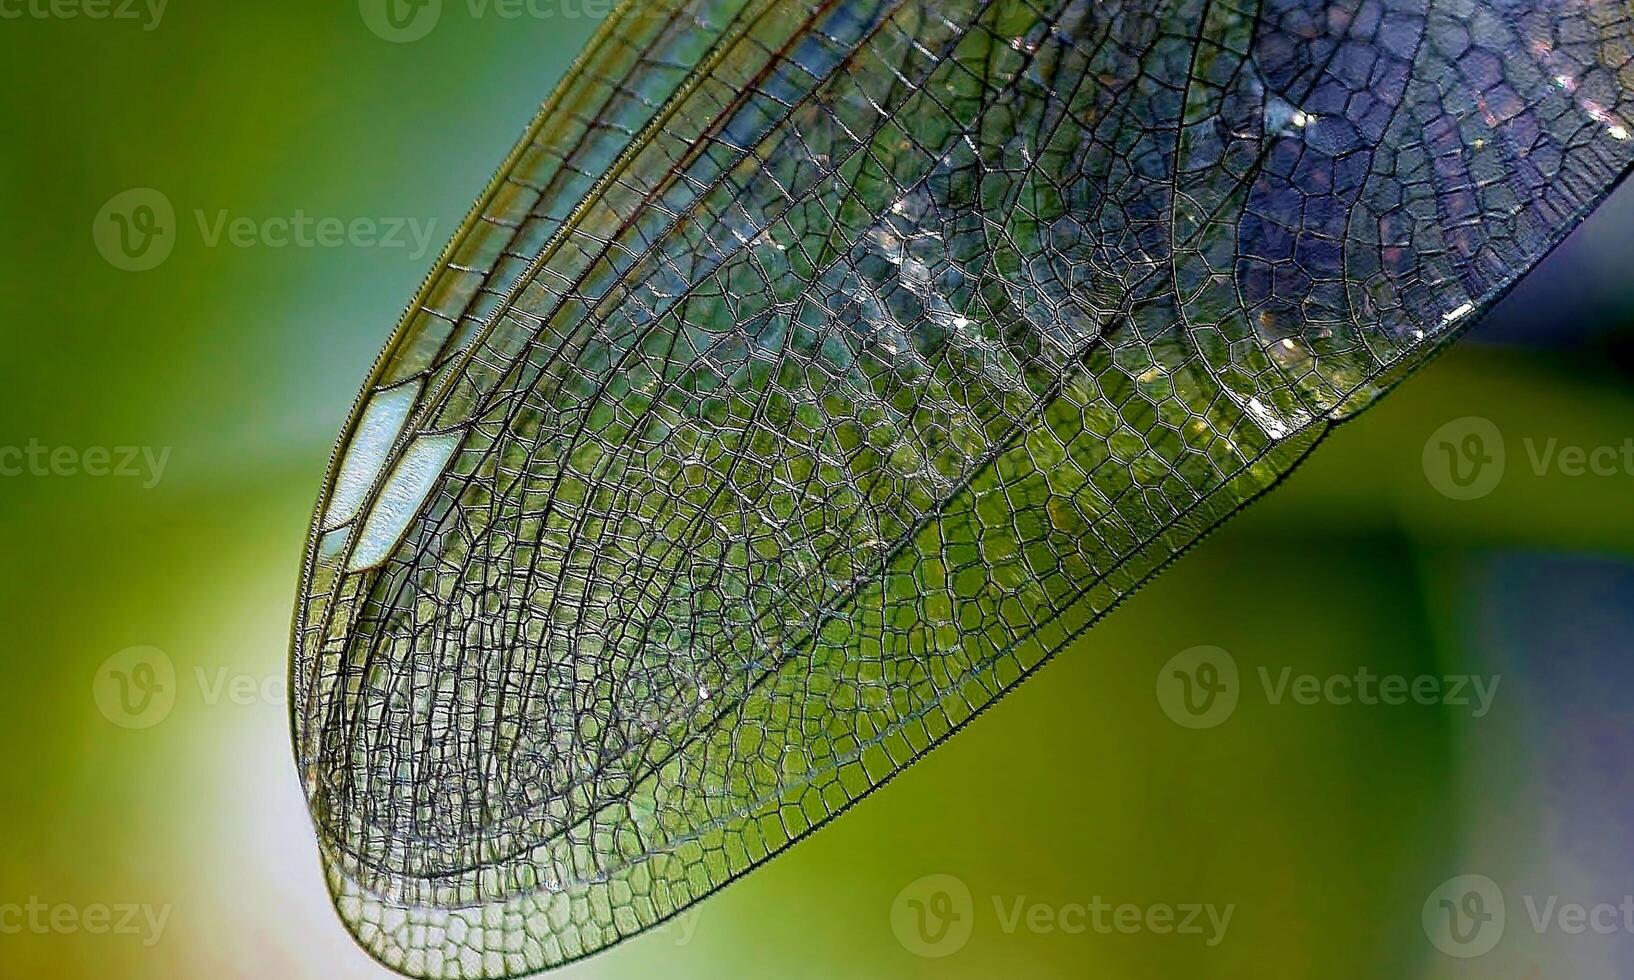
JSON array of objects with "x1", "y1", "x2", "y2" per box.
[{"x1": 0, "y1": 0, "x2": 1634, "y2": 980}]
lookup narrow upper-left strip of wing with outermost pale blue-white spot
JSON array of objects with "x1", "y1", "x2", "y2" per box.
[{"x1": 291, "y1": 0, "x2": 761, "y2": 764}]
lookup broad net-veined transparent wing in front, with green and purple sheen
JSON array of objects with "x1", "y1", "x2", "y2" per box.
[{"x1": 296, "y1": 0, "x2": 1634, "y2": 977}]
